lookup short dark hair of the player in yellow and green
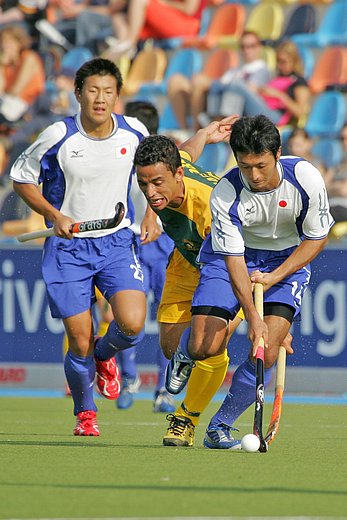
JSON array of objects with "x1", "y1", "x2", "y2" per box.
[{"x1": 134, "y1": 135, "x2": 182, "y2": 174}]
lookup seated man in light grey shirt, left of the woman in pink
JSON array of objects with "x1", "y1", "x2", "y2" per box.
[{"x1": 168, "y1": 31, "x2": 270, "y2": 131}]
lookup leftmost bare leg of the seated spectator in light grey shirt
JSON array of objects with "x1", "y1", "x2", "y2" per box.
[{"x1": 167, "y1": 74, "x2": 192, "y2": 128}]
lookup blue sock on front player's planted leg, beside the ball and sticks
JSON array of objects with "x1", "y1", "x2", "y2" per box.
[{"x1": 209, "y1": 359, "x2": 272, "y2": 426}]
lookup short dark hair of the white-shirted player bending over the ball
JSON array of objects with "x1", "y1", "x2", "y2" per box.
[{"x1": 230, "y1": 115, "x2": 281, "y2": 159}]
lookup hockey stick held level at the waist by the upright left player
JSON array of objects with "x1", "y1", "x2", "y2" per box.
[{"x1": 17, "y1": 202, "x2": 125, "y2": 242}]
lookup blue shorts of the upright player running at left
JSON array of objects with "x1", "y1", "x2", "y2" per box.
[{"x1": 42, "y1": 229, "x2": 145, "y2": 318}]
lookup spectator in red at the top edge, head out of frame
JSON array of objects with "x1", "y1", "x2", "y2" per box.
[{"x1": 108, "y1": 0, "x2": 207, "y2": 54}]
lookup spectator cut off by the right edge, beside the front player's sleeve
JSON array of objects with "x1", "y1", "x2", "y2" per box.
[{"x1": 328, "y1": 126, "x2": 347, "y2": 222}]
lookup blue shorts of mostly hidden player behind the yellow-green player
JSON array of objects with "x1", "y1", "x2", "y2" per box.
[{"x1": 139, "y1": 233, "x2": 174, "y2": 305}]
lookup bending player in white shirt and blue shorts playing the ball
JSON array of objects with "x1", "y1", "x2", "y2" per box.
[{"x1": 166, "y1": 115, "x2": 334, "y2": 449}]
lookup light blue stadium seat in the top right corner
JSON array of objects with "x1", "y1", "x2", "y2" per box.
[{"x1": 292, "y1": 0, "x2": 347, "y2": 48}]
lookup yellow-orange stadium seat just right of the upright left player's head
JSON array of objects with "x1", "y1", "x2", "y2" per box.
[{"x1": 122, "y1": 47, "x2": 167, "y2": 96}]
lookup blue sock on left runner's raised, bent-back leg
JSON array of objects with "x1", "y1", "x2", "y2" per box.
[{"x1": 94, "y1": 321, "x2": 145, "y2": 361}]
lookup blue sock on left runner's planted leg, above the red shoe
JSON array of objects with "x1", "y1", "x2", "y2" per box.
[{"x1": 64, "y1": 350, "x2": 98, "y2": 415}]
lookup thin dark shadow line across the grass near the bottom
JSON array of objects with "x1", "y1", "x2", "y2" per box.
[{"x1": 1, "y1": 482, "x2": 346, "y2": 496}]
